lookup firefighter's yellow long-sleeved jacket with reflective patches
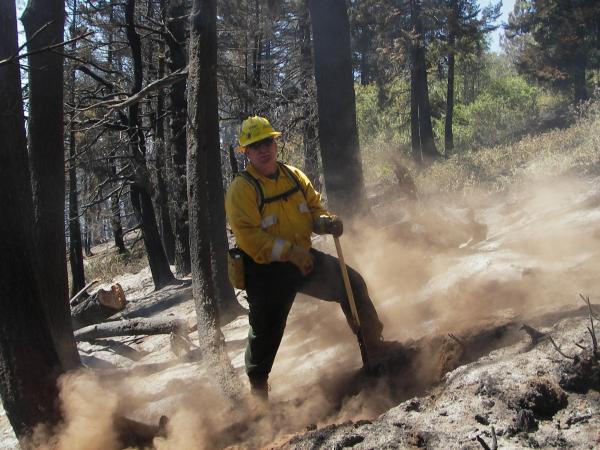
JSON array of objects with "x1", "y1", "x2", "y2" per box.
[{"x1": 225, "y1": 164, "x2": 329, "y2": 264}]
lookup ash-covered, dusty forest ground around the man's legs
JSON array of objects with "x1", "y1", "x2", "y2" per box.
[{"x1": 0, "y1": 172, "x2": 600, "y2": 450}]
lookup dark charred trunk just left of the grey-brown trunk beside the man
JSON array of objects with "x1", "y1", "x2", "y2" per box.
[{"x1": 166, "y1": 0, "x2": 191, "y2": 276}]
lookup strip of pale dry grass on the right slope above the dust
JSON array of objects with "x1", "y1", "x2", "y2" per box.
[{"x1": 416, "y1": 102, "x2": 600, "y2": 194}]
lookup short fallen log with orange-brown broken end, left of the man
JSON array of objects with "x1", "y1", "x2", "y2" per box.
[{"x1": 71, "y1": 283, "x2": 127, "y2": 330}]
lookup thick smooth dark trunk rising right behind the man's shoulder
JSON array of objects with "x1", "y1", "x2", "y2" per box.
[{"x1": 308, "y1": 0, "x2": 365, "y2": 216}]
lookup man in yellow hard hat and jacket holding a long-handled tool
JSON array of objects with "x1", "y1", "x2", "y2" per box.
[{"x1": 225, "y1": 116, "x2": 383, "y2": 399}]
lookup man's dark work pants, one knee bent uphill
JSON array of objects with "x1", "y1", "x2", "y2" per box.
[{"x1": 244, "y1": 249, "x2": 383, "y2": 380}]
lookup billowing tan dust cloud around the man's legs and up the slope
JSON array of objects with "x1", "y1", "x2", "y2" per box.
[{"x1": 29, "y1": 174, "x2": 600, "y2": 450}]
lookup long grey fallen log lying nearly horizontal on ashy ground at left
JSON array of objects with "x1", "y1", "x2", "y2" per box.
[{"x1": 74, "y1": 318, "x2": 189, "y2": 341}]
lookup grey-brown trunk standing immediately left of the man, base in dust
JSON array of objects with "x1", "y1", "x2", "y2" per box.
[{"x1": 187, "y1": 0, "x2": 240, "y2": 399}]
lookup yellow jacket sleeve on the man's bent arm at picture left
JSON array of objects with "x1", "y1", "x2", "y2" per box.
[{"x1": 225, "y1": 177, "x2": 292, "y2": 264}]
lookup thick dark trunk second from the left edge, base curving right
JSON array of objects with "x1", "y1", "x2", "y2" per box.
[{"x1": 22, "y1": 0, "x2": 80, "y2": 369}]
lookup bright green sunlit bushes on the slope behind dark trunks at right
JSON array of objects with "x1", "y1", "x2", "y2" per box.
[{"x1": 355, "y1": 54, "x2": 565, "y2": 181}]
